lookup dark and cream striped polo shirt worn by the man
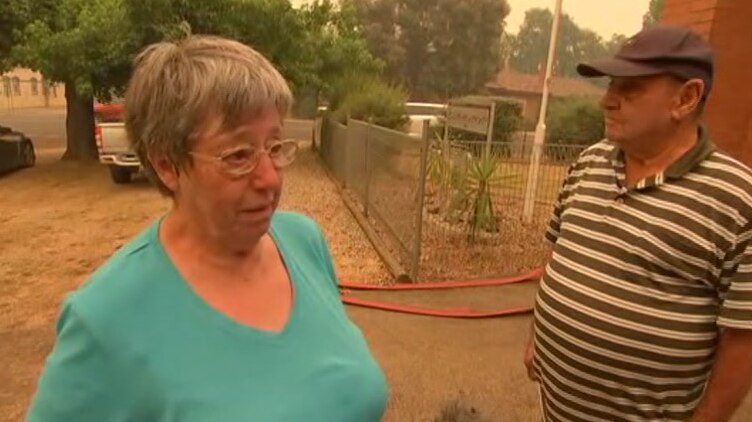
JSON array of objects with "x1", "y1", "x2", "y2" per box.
[{"x1": 534, "y1": 131, "x2": 752, "y2": 421}]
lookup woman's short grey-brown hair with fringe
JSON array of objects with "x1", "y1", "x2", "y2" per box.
[{"x1": 125, "y1": 36, "x2": 293, "y2": 196}]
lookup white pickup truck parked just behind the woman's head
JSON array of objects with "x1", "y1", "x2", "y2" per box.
[{"x1": 94, "y1": 123, "x2": 143, "y2": 184}]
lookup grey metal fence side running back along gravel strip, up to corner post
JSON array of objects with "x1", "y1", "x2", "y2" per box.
[{"x1": 319, "y1": 120, "x2": 427, "y2": 278}]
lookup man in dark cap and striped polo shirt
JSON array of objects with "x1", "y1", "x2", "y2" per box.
[{"x1": 525, "y1": 25, "x2": 752, "y2": 422}]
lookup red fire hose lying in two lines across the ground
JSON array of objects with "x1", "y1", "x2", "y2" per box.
[{"x1": 340, "y1": 268, "x2": 543, "y2": 319}]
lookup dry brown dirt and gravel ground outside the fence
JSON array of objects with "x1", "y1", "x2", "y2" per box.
[{"x1": 0, "y1": 143, "x2": 751, "y2": 422}]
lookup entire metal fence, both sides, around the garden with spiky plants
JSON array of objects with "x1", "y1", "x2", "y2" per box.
[{"x1": 319, "y1": 120, "x2": 585, "y2": 280}]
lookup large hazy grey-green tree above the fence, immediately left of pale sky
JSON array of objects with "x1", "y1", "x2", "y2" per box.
[{"x1": 348, "y1": 0, "x2": 510, "y2": 99}]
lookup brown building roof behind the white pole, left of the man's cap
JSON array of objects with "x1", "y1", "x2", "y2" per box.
[{"x1": 486, "y1": 68, "x2": 605, "y2": 96}]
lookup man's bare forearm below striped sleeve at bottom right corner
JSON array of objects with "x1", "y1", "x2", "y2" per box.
[{"x1": 692, "y1": 328, "x2": 752, "y2": 422}]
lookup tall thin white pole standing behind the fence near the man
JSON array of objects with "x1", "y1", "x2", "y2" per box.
[{"x1": 522, "y1": 0, "x2": 562, "y2": 223}]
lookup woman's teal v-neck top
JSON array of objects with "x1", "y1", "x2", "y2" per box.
[{"x1": 27, "y1": 212, "x2": 388, "y2": 422}]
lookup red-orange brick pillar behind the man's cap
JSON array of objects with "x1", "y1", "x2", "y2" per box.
[{"x1": 662, "y1": 0, "x2": 752, "y2": 166}]
